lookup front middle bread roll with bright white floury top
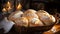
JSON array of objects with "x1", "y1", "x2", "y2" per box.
[{"x1": 29, "y1": 18, "x2": 43, "y2": 27}]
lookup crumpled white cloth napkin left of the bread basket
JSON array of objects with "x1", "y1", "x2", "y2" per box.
[{"x1": 0, "y1": 17, "x2": 15, "y2": 33}]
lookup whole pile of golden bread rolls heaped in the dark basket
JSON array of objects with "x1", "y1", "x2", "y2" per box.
[{"x1": 8, "y1": 9, "x2": 55, "y2": 27}]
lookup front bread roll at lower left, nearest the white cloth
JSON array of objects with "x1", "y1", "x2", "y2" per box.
[{"x1": 15, "y1": 17, "x2": 28, "y2": 27}]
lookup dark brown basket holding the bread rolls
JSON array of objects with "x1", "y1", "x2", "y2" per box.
[{"x1": 14, "y1": 23, "x2": 55, "y2": 34}]
